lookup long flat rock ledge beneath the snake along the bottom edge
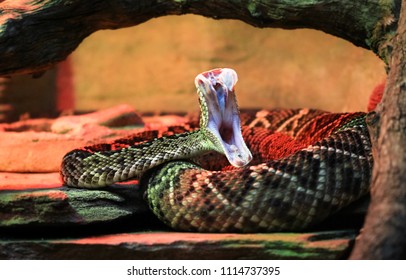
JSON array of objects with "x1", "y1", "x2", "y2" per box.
[{"x1": 0, "y1": 230, "x2": 356, "y2": 260}]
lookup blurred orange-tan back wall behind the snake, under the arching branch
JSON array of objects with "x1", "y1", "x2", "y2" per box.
[{"x1": 0, "y1": 15, "x2": 386, "y2": 120}]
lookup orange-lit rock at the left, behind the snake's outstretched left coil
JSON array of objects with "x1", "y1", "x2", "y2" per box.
[{"x1": 0, "y1": 105, "x2": 143, "y2": 172}]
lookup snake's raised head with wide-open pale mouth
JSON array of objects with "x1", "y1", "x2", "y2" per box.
[{"x1": 195, "y1": 68, "x2": 252, "y2": 167}]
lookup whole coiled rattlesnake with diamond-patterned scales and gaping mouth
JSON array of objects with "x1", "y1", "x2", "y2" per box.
[{"x1": 61, "y1": 68, "x2": 373, "y2": 232}]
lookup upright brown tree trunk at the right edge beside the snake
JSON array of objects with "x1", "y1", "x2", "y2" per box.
[{"x1": 351, "y1": 1, "x2": 406, "y2": 259}]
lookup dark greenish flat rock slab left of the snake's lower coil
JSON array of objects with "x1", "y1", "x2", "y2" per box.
[{"x1": 0, "y1": 184, "x2": 148, "y2": 230}]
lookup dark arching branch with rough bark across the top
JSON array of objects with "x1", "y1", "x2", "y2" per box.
[{"x1": 0, "y1": 0, "x2": 401, "y2": 75}]
